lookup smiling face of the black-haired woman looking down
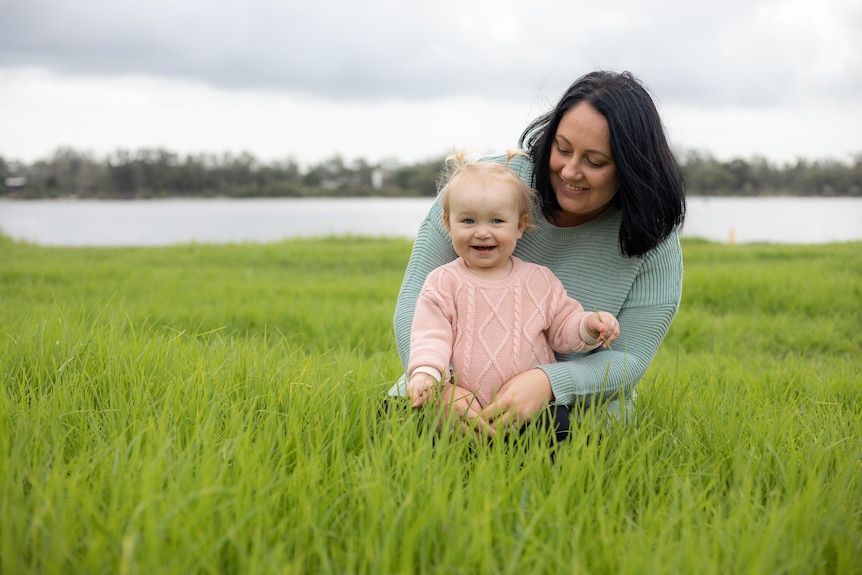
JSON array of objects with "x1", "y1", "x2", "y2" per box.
[{"x1": 549, "y1": 102, "x2": 619, "y2": 227}]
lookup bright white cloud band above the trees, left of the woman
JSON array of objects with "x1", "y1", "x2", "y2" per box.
[{"x1": 0, "y1": 70, "x2": 535, "y2": 163}]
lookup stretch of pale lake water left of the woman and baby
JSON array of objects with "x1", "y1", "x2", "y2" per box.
[{"x1": 0, "y1": 198, "x2": 432, "y2": 246}]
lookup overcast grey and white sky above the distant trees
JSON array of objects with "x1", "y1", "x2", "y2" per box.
[{"x1": 0, "y1": 0, "x2": 862, "y2": 168}]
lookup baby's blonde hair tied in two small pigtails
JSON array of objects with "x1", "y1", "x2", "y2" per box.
[{"x1": 437, "y1": 150, "x2": 538, "y2": 228}]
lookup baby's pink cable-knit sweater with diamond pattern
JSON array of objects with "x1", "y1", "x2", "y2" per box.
[{"x1": 407, "y1": 256, "x2": 598, "y2": 406}]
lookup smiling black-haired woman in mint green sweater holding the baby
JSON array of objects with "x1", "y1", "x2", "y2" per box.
[{"x1": 390, "y1": 71, "x2": 685, "y2": 436}]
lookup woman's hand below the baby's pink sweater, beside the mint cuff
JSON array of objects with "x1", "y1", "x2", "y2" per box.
[{"x1": 477, "y1": 369, "x2": 554, "y2": 433}]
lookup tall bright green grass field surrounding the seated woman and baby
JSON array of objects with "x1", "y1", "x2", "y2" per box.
[{"x1": 0, "y1": 237, "x2": 862, "y2": 575}]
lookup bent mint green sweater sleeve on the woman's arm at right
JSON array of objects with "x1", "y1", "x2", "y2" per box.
[{"x1": 541, "y1": 234, "x2": 682, "y2": 406}]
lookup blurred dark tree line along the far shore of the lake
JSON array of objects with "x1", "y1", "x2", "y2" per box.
[{"x1": 0, "y1": 148, "x2": 862, "y2": 199}]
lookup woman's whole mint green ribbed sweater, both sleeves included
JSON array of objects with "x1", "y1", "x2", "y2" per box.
[{"x1": 390, "y1": 156, "x2": 682, "y2": 412}]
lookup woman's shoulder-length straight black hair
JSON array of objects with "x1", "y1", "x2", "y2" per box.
[{"x1": 518, "y1": 71, "x2": 686, "y2": 256}]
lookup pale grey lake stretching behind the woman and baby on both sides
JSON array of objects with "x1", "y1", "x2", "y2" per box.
[{"x1": 0, "y1": 197, "x2": 862, "y2": 246}]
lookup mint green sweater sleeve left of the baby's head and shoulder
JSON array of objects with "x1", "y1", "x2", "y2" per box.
[{"x1": 393, "y1": 202, "x2": 457, "y2": 369}]
